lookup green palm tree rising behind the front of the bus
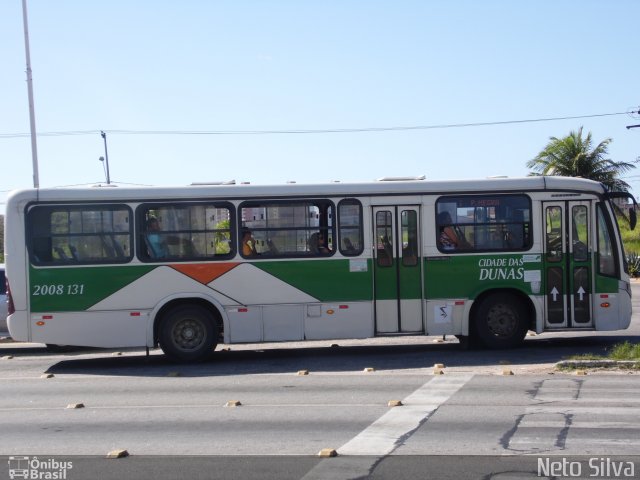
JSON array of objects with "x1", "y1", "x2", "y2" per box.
[{"x1": 527, "y1": 127, "x2": 636, "y2": 192}]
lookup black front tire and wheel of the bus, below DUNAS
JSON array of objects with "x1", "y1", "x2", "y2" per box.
[{"x1": 474, "y1": 293, "x2": 529, "y2": 348}]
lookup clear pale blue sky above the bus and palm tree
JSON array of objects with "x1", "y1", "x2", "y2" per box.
[{"x1": 0, "y1": 0, "x2": 640, "y2": 204}]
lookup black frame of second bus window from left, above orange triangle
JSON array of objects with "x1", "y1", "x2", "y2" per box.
[{"x1": 135, "y1": 200, "x2": 236, "y2": 263}]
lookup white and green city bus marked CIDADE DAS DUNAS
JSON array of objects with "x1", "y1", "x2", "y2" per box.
[{"x1": 5, "y1": 177, "x2": 635, "y2": 361}]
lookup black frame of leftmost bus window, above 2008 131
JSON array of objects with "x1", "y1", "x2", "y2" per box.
[{"x1": 24, "y1": 202, "x2": 135, "y2": 267}]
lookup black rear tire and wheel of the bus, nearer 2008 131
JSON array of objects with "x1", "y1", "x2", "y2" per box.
[{"x1": 158, "y1": 305, "x2": 218, "y2": 362}]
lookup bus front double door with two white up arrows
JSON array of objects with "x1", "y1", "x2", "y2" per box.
[{"x1": 543, "y1": 201, "x2": 594, "y2": 329}]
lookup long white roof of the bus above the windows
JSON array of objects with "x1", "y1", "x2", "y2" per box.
[{"x1": 7, "y1": 176, "x2": 606, "y2": 203}]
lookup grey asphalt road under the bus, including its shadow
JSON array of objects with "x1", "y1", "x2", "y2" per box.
[{"x1": 0, "y1": 285, "x2": 640, "y2": 480}]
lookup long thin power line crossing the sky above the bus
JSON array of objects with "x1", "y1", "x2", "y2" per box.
[{"x1": 0, "y1": 111, "x2": 636, "y2": 139}]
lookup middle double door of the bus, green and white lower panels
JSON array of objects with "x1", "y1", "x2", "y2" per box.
[{"x1": 373, "y1": 205, "x2": 424, "y2": 334}]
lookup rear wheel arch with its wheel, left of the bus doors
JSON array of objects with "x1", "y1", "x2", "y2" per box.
[{"x1": 153, "y1": 298, "x2": 224, "y2": 362}]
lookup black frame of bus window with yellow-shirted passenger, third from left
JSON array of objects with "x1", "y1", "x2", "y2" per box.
[{"x1": 236, "y1": 197, "x2": 338, "y2": 260}]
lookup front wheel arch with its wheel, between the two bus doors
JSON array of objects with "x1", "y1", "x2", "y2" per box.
[{"x1": 469, "y1": 289, "x2": 536, "y2": 349}]
